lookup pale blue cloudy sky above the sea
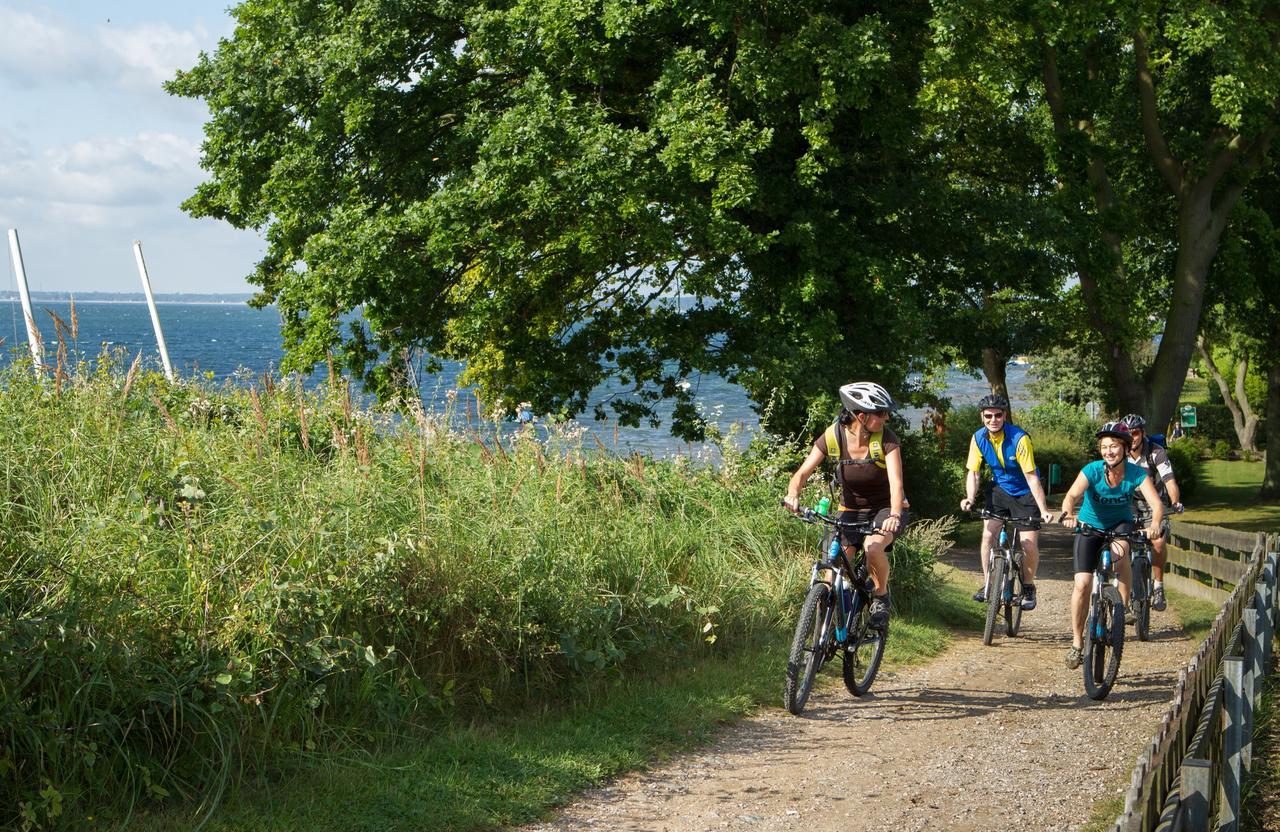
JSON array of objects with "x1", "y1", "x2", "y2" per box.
[{"x1": 0, "y1": 0, "x2": 265, "y2": 293}]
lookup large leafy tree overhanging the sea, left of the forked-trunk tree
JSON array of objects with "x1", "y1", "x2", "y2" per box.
[{"x1": 169, "y1": 0, "x2": 940, "y2": 434}]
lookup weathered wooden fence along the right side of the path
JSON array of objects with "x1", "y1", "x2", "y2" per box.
[{"x1": 1112, "y1": 522, "x2": 1280, "y2": 832}]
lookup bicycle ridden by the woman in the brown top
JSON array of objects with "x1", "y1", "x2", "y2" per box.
[{"x1": 783, "y1": 508, "x2": 888, "y2": 714}]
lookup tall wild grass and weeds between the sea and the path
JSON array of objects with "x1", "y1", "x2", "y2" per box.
[{"x1": 0, "y1": 361, "x2": 938, "y2": 828}]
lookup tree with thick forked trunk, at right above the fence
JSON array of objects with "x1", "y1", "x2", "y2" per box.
[{"x1": 932, "y1": 0, "x2": 1280, "y2": 424}]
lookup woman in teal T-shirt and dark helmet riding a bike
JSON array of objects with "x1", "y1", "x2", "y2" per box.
[{"x1": 1062, "y1": 422, "x2": 1165, "y2": 669}]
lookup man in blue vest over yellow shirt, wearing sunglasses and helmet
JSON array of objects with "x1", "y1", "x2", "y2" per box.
[{"x1": 960, "y1": 396, "x2": 1053, "y2": 611}]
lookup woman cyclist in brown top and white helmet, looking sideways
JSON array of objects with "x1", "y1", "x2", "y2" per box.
[{"x1": 782, "y1": 381, "x2": 908, "y2": 630}]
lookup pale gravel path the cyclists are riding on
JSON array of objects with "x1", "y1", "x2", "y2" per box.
[{"x1": 525, "y1": 529, "x2": 1196, "y2": 832}]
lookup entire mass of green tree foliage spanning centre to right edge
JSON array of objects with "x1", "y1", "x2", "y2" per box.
[{"x1": 169, "y1": 0, "x2": 1280, "y2": 436}]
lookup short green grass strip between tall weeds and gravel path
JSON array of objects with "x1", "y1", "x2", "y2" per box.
[{"x1": 128, "y1": 567, "x2": 982, "y2": 832}]
